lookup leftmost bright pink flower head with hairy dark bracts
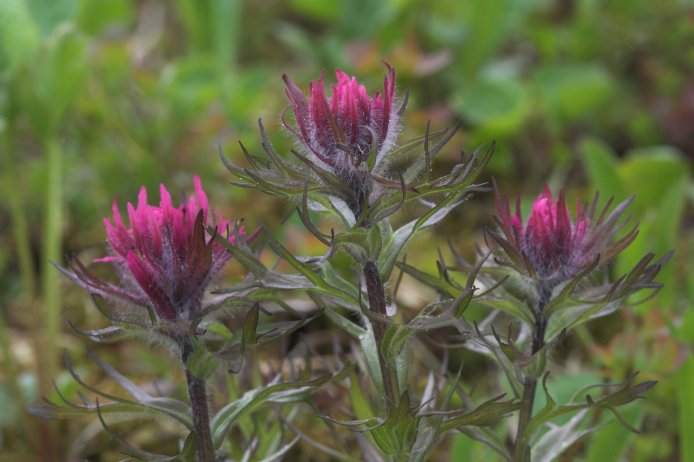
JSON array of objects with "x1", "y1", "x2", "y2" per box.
[{"x1": 71, "y1": 175, "x2": 243, "y2": 321}]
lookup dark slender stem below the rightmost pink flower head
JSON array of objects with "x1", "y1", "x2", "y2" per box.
[{"x1": 514, "y1": 288, "x2": 551, "y2": 462}]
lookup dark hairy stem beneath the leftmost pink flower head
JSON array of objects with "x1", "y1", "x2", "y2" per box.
[{"x1": 181, "y1": 340, "x2": 215, "y2": 462}]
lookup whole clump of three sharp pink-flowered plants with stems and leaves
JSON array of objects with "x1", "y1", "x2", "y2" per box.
[{"x1": 43, "y1": 64, "x2": 669, "y2": 462}]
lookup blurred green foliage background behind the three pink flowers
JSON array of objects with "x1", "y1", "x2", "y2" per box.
[{"x1": 0, "y1": 0, "x2": 694, "y2": 462}]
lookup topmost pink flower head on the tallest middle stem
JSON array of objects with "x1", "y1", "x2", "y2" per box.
[{"x1": 282, "y1": 64, "x2": 399, "y2": 174}]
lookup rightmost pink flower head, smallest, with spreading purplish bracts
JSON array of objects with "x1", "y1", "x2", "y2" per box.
[{"x1": 497, "y1": 186, "x2": 636, "y2": 282}]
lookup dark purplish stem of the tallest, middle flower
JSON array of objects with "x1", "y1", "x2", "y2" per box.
[{"x1": 363, "y1": 261, "x2": 400, "y2": 413}]
